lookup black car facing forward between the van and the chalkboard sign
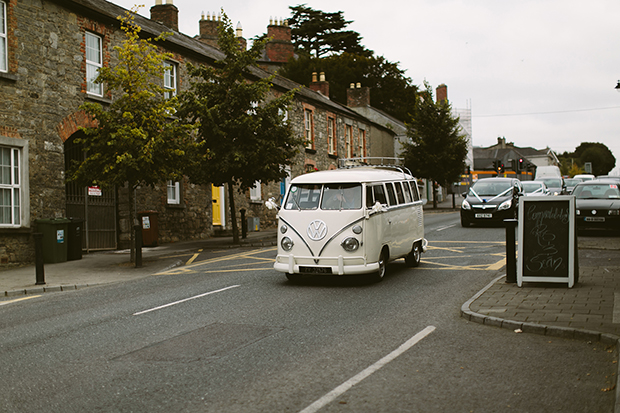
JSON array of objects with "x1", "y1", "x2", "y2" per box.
[{"x1": 461, "y1": 178, "x2": 523, "y2": 227}]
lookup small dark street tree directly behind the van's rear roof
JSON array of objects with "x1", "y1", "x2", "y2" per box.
[{"x1": 404, "y1": 82, "x2": 467, "y2": 208}]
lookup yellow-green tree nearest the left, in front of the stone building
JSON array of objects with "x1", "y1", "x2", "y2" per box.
[{"x1": 68, "y1": 11, "x2": 193, "y2": 259}]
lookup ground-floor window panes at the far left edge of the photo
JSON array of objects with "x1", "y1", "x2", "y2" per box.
[{"x1": 0, "y1": 146, "x2": 22, "y2": 227}]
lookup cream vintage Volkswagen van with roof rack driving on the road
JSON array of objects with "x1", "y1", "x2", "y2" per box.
[{"x1": 266, "y1": 166, "x2": 427, "y2": 281}]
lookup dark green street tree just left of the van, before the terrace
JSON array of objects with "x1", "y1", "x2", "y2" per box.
[{"x1": 179, "y1": 13, "x2": 303, "y2": 243}]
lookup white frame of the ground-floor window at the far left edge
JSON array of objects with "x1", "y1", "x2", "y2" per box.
[{"x1": 0, "y1": 136, "x2": 30, "y2": 228}]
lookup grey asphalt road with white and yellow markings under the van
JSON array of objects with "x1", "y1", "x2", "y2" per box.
[{"x1": 0, "y1": 213, "x2": 617, "y2": 413}]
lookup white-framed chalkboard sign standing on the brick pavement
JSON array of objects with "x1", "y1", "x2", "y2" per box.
[{"x1": 517, "y1": 196, "x2": 578, "y2": 287}]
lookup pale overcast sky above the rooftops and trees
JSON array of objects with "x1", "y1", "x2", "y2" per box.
[{"x1": 112, "y1": 0, "x2": 620, "y2": 174}]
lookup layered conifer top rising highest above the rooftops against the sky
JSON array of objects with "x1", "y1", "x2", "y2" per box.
[{"x1": 288, "y1": 4, "x2": 367, "y2": 58}]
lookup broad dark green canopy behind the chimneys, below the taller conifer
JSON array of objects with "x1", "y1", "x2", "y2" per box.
[{"x1": 280, "y1": 52, "x2": 417, "y2": 121}]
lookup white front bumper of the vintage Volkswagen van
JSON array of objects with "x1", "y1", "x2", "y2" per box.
[{"x1": 273, "y1": 255, "x2": 379, "y2": 275}]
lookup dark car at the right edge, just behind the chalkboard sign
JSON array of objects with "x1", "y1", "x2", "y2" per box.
[{"x1": 573, "y1": 179, "x2": 620, "y2": 231}]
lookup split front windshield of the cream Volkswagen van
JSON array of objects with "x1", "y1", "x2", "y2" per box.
[{"x1": 284, "y1": 184, "x2": 362, "y2": 210}]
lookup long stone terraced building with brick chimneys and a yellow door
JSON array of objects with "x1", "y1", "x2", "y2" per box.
[{"x1": 0, "y1": 0, "x2": 398, "y2": 266}]
